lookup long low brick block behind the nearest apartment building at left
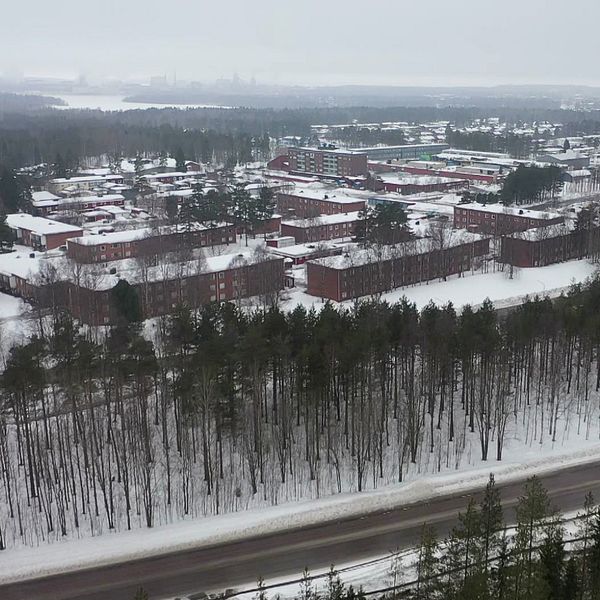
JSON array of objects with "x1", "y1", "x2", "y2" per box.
[{"x1": 67, "y1": 224, "x2": 236, "y2": 263}]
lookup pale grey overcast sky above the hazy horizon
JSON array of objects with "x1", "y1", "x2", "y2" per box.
[{"x1": 0, "y1": 0, "x2": 600, "y2": 85}]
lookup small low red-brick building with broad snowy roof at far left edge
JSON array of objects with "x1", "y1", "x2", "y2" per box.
[{"x1": 6, "y1": 213, "x2": 83, "y2": 250}]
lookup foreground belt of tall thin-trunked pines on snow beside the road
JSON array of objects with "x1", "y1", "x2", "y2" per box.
[{"x1": 0, "y1": 279, "x2": 600, "y2": 549}]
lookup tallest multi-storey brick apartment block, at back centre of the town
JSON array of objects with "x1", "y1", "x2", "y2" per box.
[{"x1": 287, "y1": 148, "x2": 369, "y2": 177}]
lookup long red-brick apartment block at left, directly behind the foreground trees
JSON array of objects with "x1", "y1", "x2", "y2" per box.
[{"x1": 0, "y1": 247, "x2": 284, "y2": 325}]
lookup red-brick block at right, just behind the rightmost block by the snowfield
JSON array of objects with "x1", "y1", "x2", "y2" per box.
[{"x1": 454, "y1": 203, "x2": 564, "y2": 235}]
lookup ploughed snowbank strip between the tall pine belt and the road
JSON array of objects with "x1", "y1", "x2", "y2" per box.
[{"x1": 0, "y1": 423, "x2": 600, "y2": 583}]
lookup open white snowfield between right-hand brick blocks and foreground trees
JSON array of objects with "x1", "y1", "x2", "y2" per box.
[{"x1": 284, "y1": 260, "x2": 597, "y2": 310}]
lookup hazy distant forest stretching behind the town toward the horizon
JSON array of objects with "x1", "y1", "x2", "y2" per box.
[{"x1": 0, "y1": 100, "x2": 600, "y2": 168}]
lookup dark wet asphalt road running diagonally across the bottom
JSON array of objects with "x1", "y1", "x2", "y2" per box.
[{"x1": 0, "y1": 461, "x2": 600, "y2": 600}]
